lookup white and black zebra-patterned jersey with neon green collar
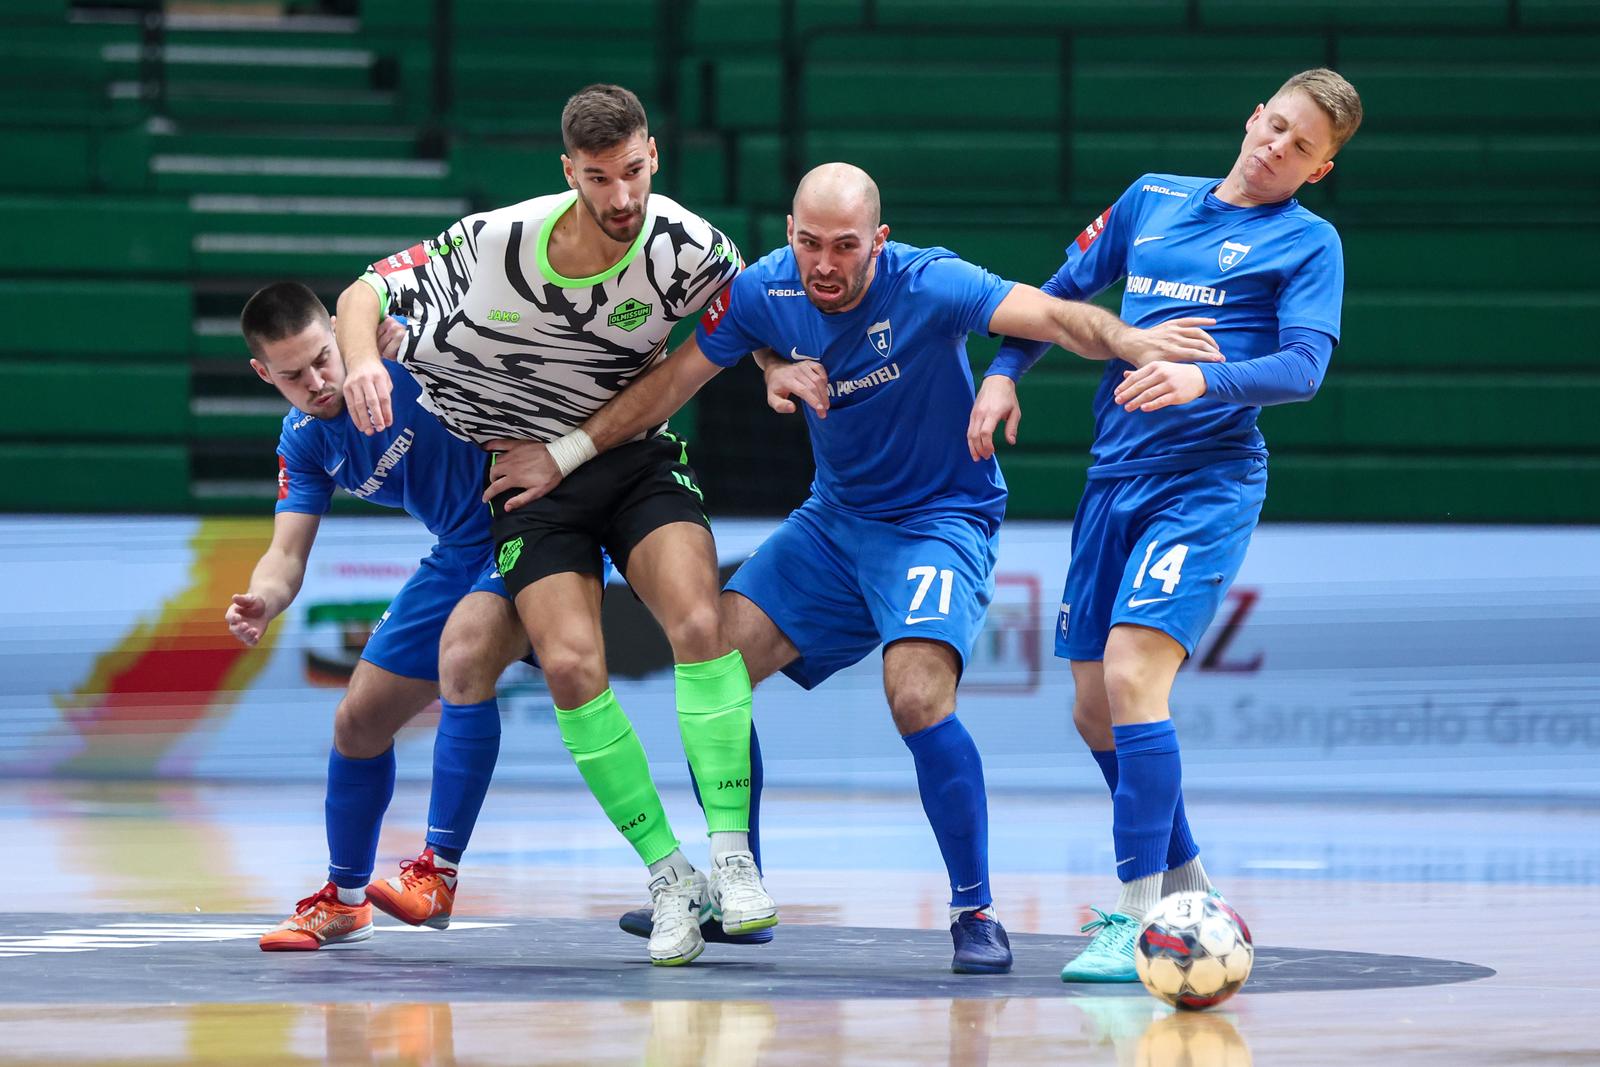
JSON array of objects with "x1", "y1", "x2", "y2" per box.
[{"x1": 363, "y1": 192, "x2": 742, "y2": 443}]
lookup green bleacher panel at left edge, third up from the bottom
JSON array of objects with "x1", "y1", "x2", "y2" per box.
[{"x1": 0, "y1": 278, "x2": 194, "y2": 358}]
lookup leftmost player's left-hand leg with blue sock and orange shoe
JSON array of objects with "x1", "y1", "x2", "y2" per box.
[{"x1": 261, "y1": 659, "x2": 438, "y2": 952}]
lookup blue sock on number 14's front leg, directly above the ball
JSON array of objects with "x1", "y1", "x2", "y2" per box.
[{"x1": 1112, "y1": 718, "x2": 1182, "y2": 881}]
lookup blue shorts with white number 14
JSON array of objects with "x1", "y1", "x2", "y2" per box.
[{"x1": 1056, "y1": 459, "x2": 1267, "y2": 659}]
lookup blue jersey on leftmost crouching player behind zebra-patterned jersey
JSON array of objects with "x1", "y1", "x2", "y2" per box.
[{"x1": 277, "y1": 360, "x2": 490, "y2": 552}]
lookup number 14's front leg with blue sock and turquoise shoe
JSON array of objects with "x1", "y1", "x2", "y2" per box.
[{"x1": 1061, "y1": 624, "x2": 1187, "y2": 982}]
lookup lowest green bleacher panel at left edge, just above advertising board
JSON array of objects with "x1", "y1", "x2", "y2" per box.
[{"x1": 0, "y1": 443, "x2": 190, "y2": 512}]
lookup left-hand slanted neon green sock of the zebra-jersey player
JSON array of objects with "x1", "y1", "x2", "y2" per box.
[{"x1": 555, "y1": 689, "x2": 678, "y2": 864}]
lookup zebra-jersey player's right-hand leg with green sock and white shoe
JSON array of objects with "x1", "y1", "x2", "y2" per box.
[{"x1": 627, "y1": 523, "x2": 778, "y2": 934}]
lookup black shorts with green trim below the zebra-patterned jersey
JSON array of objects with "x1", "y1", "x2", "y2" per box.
[{"x1": 490, "y1": 430, "x2": 710, "y2": 600}]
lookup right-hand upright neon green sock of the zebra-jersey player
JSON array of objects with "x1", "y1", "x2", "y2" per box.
[{"x1": 674, "y1": 649, "x2": 750, "y2": 833}]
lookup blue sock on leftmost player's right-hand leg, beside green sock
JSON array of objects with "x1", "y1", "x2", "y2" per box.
[{"x1": 427, "y1": 697, "x2": 499, "y2": 864}]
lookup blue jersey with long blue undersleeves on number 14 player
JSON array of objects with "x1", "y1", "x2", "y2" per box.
[{"x1": 989, "y1": 174, "x2": 1344, "y2": 478}]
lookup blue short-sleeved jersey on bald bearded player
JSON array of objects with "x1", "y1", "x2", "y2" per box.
[{"x1": 696, "y1": 242, "x2": 1014, "y2": 525}]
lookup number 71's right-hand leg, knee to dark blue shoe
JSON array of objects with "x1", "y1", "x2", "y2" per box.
[{"x1": 883, "y1": 640, "x2": 1011, "y2": 974}]
